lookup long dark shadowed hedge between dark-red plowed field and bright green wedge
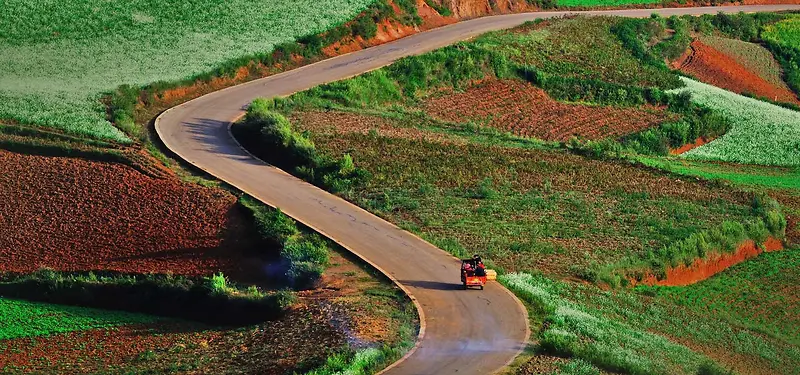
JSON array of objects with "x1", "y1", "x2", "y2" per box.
[{"x1": 0, "y1": 270, "x2": 294, "y2": 326}]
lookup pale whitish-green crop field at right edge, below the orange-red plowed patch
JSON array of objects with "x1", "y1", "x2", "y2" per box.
[{"x1": 682, "y1": 78, "x2": 800, "y2": 167}]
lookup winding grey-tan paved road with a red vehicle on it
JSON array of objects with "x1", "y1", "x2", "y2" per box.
[{"x1": 156, "y1": 5, "x2": 800, "y2": 375}]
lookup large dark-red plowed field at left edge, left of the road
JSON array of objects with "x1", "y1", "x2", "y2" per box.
[{"x1": 0, "y1": 150, "x2": 250, "y2": 275}]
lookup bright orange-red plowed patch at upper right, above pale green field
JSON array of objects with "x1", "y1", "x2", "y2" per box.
[{"x1": 680, "y1": 40, "x2": 800, "y2": 104}]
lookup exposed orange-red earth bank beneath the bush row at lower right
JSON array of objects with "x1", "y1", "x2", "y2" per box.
[{"x1": 632, "y1": 237, "x2": 783, "y2": 286}]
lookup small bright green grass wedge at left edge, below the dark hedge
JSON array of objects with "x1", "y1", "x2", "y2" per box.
[{"x1": 0, "y1": 298, "x2": 157, "y2": 340}]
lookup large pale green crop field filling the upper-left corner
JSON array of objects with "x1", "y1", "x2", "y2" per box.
[{"x1": 0, "y1": 0, "x2": 372, "y2": 142}]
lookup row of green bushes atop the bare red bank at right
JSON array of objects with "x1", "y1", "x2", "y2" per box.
[{"x1": 592, "y1": 194, "x2": 787, "y2": 287}]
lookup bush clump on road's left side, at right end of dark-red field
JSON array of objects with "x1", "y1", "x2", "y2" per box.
[{"x1": 240, "y1": 196, "x2": 329, "y2": 289}]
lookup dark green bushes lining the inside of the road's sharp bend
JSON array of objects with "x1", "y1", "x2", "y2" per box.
[{"x1": 233, "y1": 98, "x2": 367, "y2": 192}]
